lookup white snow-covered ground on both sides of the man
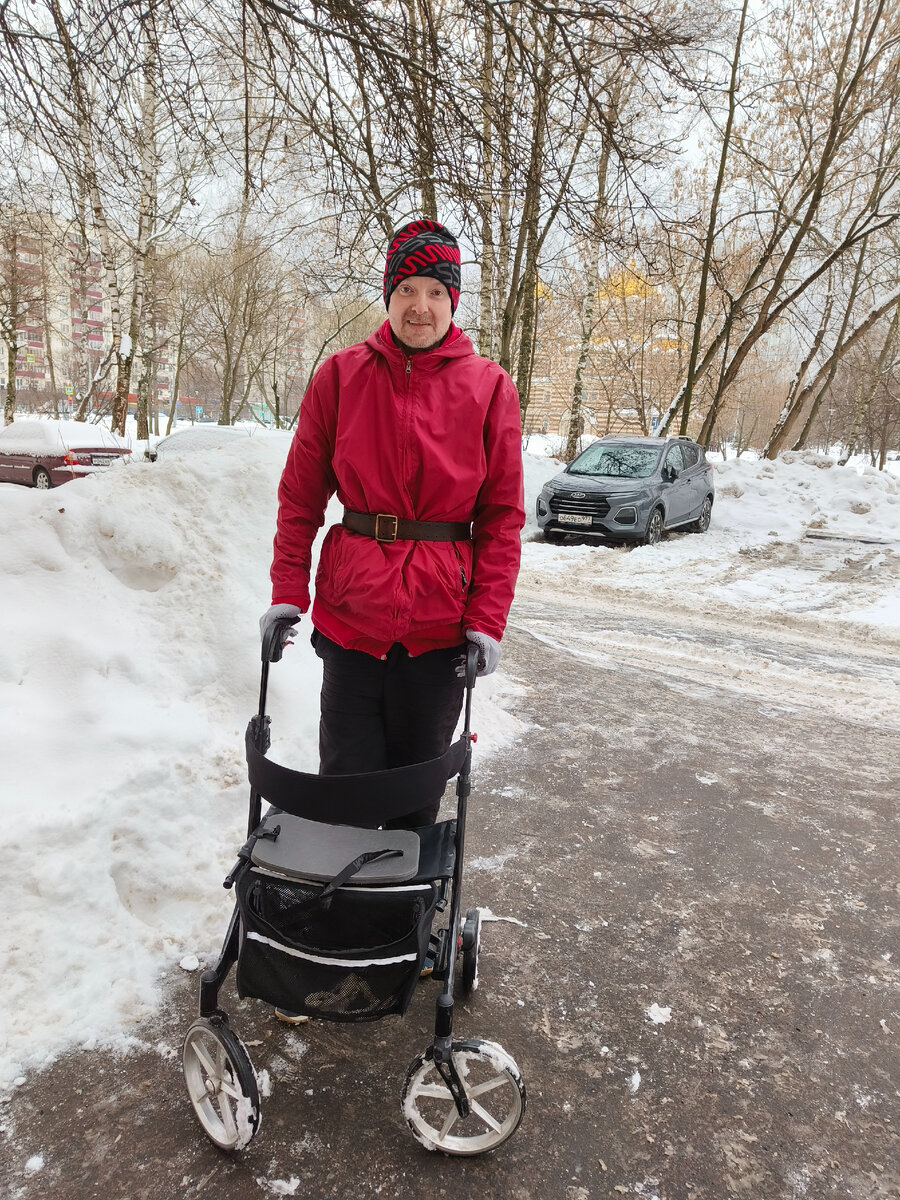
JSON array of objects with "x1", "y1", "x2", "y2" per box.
[{"x1": 0, "y1": 432, "x2": 900, "y2": 1087}]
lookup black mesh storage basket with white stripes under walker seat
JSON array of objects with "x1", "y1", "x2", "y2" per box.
[{"x1": 236, "y1": 868, "x2": 438, "y2": 1021}]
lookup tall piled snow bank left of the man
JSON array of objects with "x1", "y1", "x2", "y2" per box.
[{"x1": 0, "y1": 439, "x2": 303, "y2": 1081}]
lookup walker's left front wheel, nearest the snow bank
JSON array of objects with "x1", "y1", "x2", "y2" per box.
[{"x1": 181, "y1": 1016, "x2": 260, "y2": 1150}]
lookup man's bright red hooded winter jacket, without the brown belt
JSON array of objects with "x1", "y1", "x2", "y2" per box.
[{"x1": 271, "y1": 322, "x2": 524, "y2": 655}]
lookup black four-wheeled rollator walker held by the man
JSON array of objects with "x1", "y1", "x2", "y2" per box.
[{"x1": 182, "y1": 619, "x2": 526, "y2": 1156}]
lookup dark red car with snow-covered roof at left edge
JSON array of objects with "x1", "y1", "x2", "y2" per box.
[{"x1": 0, "y1": 420, "x2": 131, "y2": 488}]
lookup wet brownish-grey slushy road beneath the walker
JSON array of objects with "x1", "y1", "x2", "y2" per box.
[{"x1": 0, "y1": 590, "x2": 900, "y2": 1200}]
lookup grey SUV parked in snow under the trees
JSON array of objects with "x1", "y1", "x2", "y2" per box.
[{"x1": 536, "y1": 436, "x2": 715, "y2": 546}]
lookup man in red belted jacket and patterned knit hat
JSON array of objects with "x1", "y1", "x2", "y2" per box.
[{"x1": 260, "y1": 218, "x2": 524, "y2": 828}]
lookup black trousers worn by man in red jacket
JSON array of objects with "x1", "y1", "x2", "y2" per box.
[{"x1": 311, "y1": 630, "x2": 466, "y2": 829}]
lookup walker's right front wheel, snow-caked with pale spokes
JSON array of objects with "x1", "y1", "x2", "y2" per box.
[{"x1": 401, "y1": 1038, "x2": 526, "y2": 1154}]
